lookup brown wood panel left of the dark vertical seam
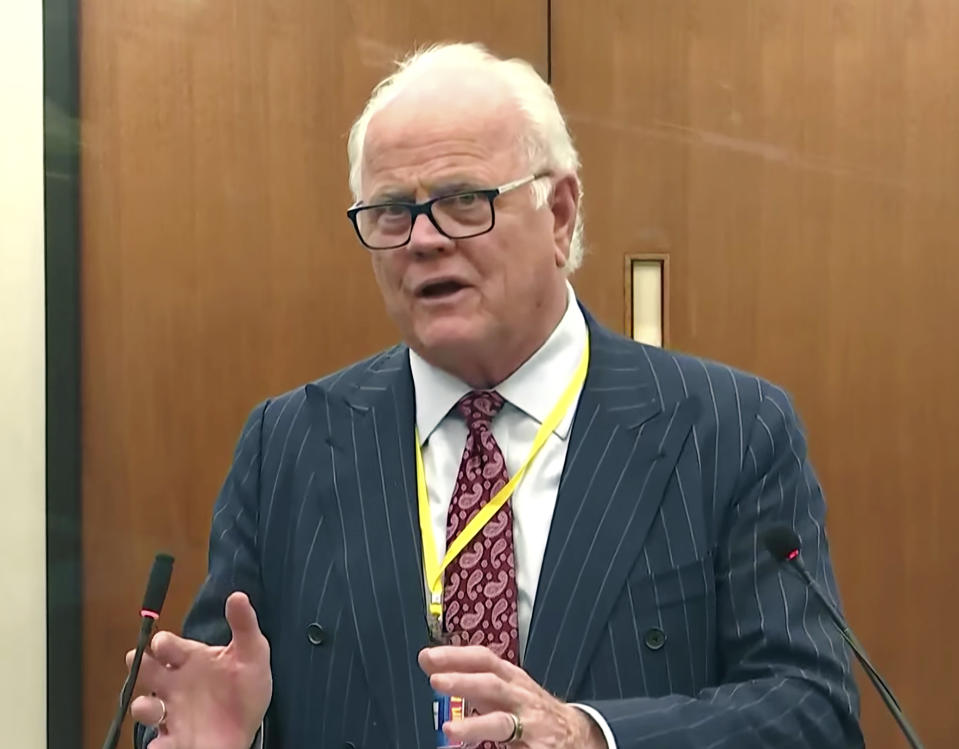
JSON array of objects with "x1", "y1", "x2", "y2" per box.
[{"x1": 80, "y1": 0, "x2": 547, "y2": 749}]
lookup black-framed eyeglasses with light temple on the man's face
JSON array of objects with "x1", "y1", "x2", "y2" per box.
[{"x1": 346, "y1": 172, "x2": 549, "y2": 250}]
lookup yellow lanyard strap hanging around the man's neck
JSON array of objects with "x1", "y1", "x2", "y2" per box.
[{"x1": 414, "y1": 340, "x2": 589, "y2": 620}]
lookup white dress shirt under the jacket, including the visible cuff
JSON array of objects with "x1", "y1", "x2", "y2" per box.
[{"x1": 410, "y1": 284, "x2": 615, "y2": 749}]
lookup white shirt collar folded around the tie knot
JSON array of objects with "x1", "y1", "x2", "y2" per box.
[{"x1": 410, "y1": 282, "x2": 587, "y2": 444}]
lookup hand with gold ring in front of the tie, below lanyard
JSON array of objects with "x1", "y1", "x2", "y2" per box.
[{"x1": 419, "y1": 646, "x2": 606, "y2": 749}]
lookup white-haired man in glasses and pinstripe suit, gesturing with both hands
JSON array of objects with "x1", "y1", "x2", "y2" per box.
[{"x1": 133, "y1": 45, "x2": 862, "y2": 749}]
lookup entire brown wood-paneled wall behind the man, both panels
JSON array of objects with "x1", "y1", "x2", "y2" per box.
[{"x1": 81, "y1": 0, "x2": 959, "y2": 749}]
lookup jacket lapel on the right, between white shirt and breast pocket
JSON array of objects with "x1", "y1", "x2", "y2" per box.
[{"x1": 523, "y1": 314, "x2": 698, "y2": 698}]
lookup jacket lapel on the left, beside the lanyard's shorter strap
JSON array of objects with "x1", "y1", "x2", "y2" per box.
[{"x1": 307, "y1": 346, "x2": 435, "y2": 746}]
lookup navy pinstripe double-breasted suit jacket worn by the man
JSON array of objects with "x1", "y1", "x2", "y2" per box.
[{"x1": 142, "y1": 315, "x2": 862, "y2": 749}]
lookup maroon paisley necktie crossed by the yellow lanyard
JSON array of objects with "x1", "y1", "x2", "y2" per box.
[{"x1": 443, "y1": 391, "x2": 519, "y2": 672}]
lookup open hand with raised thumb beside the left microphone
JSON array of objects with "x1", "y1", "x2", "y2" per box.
[{"x1": 127, "y1": 593, "x2": 273, "y2": 749}]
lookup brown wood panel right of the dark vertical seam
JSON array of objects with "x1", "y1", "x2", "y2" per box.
[{"x1": 552, "y1": 0, "x2": 959, "y2": 749}]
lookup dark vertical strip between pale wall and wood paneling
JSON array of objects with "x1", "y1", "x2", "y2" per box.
[{"x1": 43, "y1": 0, "x2": 83, "y2": 749}]
